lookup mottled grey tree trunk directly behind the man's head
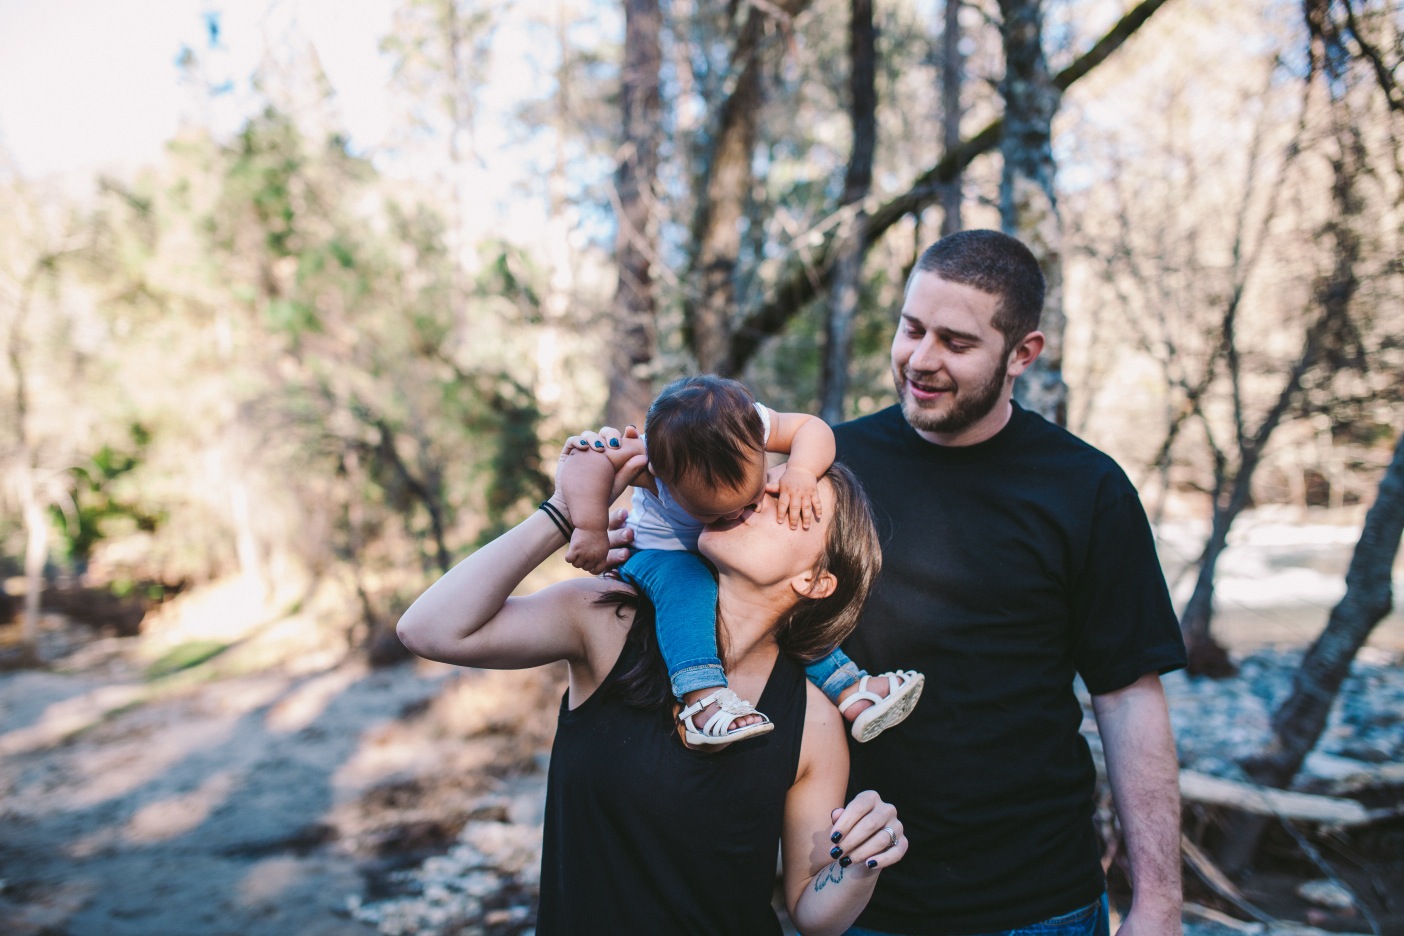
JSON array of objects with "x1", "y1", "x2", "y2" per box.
[{"x1": 1000, "y1": 0, "x2": 1067, "y2": 425}]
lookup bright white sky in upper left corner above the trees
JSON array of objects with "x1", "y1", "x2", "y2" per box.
[{"x1": 0, "y1": 0, "x2": 395, "y2": 175}]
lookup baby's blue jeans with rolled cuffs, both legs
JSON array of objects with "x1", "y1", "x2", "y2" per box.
[{"x1": 619, "y1": 549, "x2": 868, "y2": 704}]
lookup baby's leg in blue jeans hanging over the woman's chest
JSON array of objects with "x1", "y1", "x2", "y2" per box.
[{"x1": 619, "y1": 549, "x2": 764, "y2": 746}]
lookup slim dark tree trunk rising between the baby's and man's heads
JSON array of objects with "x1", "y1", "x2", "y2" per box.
[{"x1": 819, "y1": 0, "x2": 878, "y2": 424}]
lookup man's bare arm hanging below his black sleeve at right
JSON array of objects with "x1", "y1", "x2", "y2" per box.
[{"x1": 1092, "y1": 674, "x2": 1184, "y2": 936}]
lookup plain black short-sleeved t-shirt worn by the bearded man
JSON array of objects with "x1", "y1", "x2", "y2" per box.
[{"x1": 834, "y1": 404, "x2": 1185, "y2": 935}]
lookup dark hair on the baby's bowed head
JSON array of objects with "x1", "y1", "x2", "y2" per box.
[{"x1": 643, "y1": 373, "x2": 765, "y2": 488}]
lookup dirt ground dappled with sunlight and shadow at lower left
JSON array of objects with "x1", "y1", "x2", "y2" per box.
[{"x1": 0, "y1": 637, "x2": 558, "y2": 936}]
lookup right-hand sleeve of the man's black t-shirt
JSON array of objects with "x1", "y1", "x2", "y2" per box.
[{"x1": 1073, "y1": 476, "x2": 1185, "y2": 695}]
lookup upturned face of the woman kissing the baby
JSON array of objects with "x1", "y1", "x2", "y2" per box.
[{"x1": 698, "y1": 479, "x2": 834, "y2": 585}]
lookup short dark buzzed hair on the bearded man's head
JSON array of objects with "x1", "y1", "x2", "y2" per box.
[{"x1": 907, "y1": 230, "x2": 1043, "y2": 351}]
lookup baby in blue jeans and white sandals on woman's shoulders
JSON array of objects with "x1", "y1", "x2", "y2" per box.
[{"x1": 562, "y1": 375, "x2": 925, "y2": 747}]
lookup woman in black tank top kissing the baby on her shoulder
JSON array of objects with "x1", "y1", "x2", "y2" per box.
[{"x1": 399, "y1": 448, "x2": 907, "y2": 936}]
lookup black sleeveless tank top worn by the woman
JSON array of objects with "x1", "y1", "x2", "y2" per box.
[{"x1": 536, "y1": 641, "x2": 804, "y2": 936}]
